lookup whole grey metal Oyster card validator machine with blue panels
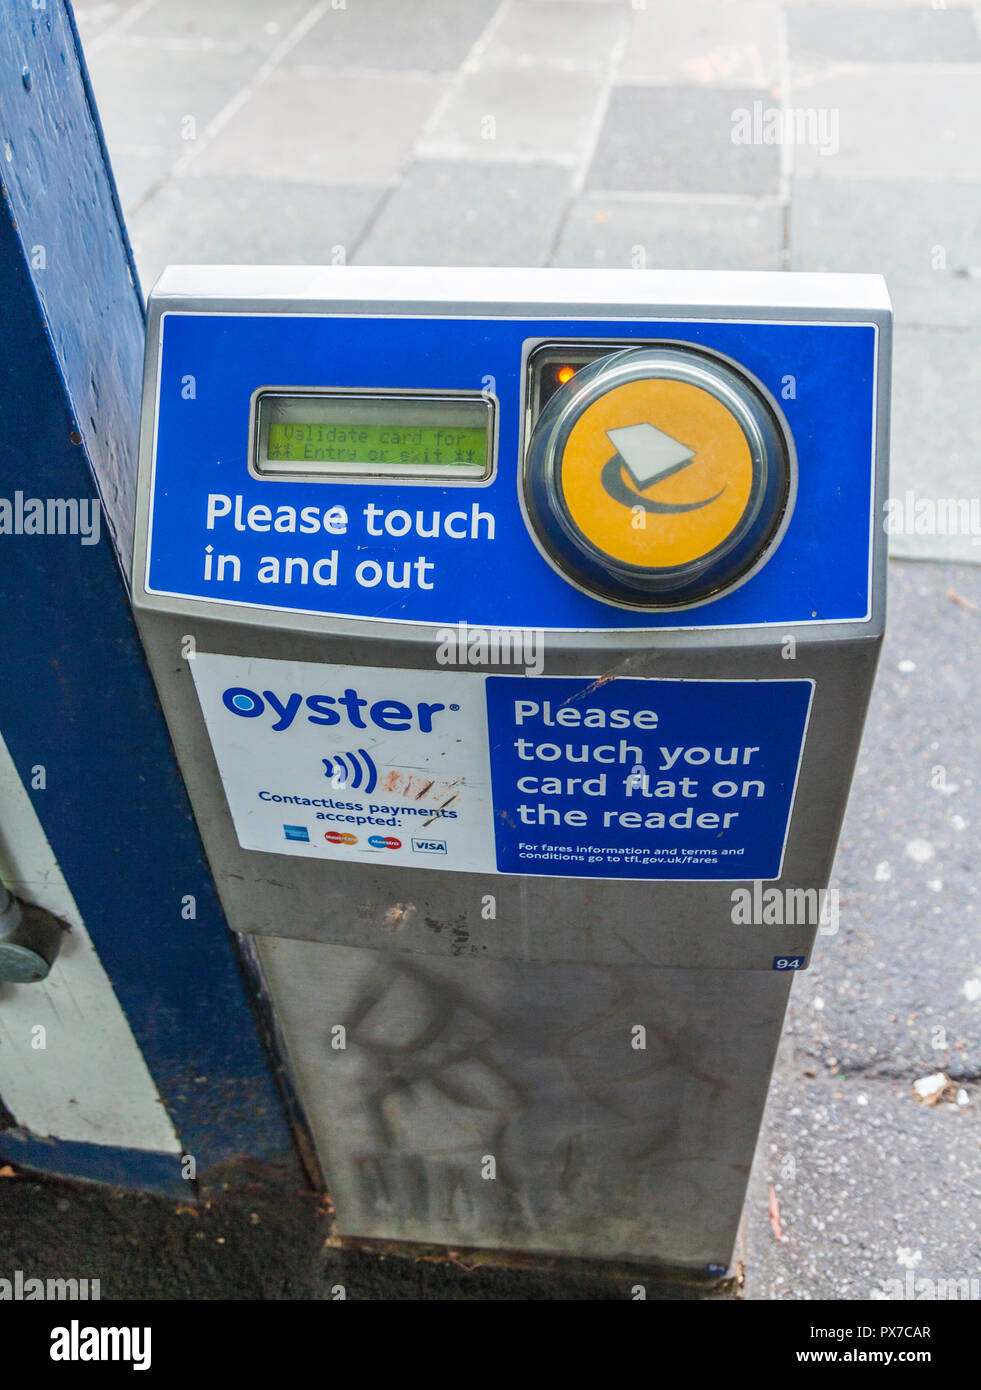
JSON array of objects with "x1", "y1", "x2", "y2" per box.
[{"x1": 133, "y1": 267, "x2": 891, "y2": 1270}]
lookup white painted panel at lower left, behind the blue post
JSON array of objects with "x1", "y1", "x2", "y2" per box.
[{"x1": 0, "y1": 737, "x2": 181, "y2": 1154}]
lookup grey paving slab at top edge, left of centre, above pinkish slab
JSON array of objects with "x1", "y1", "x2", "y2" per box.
[{"x1": 285, "y1": 0, "x2": 499, "y2": 72}]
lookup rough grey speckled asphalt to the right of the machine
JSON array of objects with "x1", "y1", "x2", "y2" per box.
[{"x1": 746, "y1": 562, "x2": 981, "y2": 1300}]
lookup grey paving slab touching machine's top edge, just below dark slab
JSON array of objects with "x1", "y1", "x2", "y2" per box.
[{"x1": 552, "y1": 193, "x2": 784, "y2": 270}]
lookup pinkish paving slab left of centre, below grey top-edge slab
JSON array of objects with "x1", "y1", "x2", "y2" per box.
[{"x1": 195, "y1": 68, "x2": 443, "y2": 185}]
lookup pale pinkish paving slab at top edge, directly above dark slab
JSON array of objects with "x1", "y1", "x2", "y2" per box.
[{"x1": 618, "y1": 0, "x2": 784, "y2": 88}]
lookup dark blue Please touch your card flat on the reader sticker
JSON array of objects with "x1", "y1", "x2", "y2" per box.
[{"x1": 486, "y1": 676, "x2": 813, "y2": 880}]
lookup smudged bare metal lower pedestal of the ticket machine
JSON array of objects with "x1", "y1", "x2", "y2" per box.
[{"x1": 257, "y1": 938, "x2": 791, "y2": 1269}]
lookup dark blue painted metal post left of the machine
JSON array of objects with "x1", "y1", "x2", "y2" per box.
[{"x1": 0, "y1": 0, "x2": 300, "y2": 1191}]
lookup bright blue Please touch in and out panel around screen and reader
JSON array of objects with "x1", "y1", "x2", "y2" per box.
[{"x1": 146, "y1": 311, "x2": 877, "y2": 630}]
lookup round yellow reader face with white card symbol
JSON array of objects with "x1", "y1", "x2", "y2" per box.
[{"x1": 559, "y1": 377, "x2": 753, "y2": 569}]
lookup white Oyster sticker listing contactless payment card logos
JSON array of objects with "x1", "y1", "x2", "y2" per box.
[{"x1": 190, "y1": 652, "x2": 496, "y2": 872}]
